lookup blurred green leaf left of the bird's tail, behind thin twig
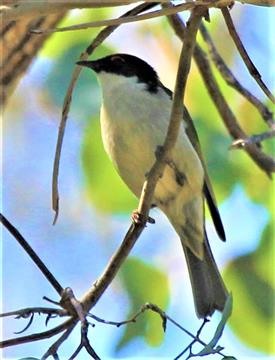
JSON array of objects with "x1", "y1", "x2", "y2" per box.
[{"x1": 116, "y1": 257, "x2": 169, "y2": 350}]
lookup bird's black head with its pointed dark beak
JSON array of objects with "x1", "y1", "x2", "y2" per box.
[{"x1": 77, "y1": 54, "x2": 160, "y2": 92}]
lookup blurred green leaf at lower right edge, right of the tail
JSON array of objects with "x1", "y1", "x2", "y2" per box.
[{"x1": 224, "y1": 224, "x2": 275, "y2": 354}]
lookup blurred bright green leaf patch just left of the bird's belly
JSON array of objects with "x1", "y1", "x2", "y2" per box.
[{"x1": 82, "y1": 118, "x2": 137, "y2": 213}]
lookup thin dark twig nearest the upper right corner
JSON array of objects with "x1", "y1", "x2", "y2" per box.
[{"x1": 221, "y1": 7, "x2": 275, "y2": 103}]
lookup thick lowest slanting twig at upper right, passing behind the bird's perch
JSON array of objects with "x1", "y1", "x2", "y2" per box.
[{"x1": 168, "y1": 11, "x2": 275, "y2": 176}]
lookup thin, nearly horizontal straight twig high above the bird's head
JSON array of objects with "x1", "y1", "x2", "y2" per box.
[{"x1": 31, "y1": 0, "x2": 225, "y2": 35}]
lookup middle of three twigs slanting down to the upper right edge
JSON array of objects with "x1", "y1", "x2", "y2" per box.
[{"x1": 200, "y1": 24, "x2": 275, "y2": 128}]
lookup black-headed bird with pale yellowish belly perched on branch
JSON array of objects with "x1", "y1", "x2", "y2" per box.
[{"x1": 76, "y1": 53, "x2": 228, "y2": 318}]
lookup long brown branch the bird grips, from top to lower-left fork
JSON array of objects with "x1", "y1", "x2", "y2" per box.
[{"x1": 81, "y1": 7, "x2": 205, "y2": 312}]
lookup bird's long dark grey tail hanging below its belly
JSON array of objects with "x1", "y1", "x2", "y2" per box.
[{"x1": 183, "y1": 234, "x2": 228, "y2": 318}]
